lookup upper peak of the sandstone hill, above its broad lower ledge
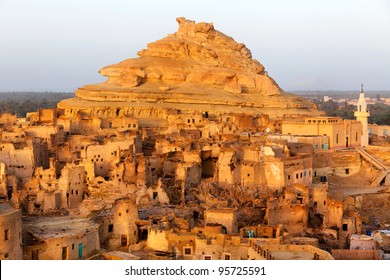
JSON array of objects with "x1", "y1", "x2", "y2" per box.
[{"x1": 100, "y1": 18, "x2": 281, "y2": 95}]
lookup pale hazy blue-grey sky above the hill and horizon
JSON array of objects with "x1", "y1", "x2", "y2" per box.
[{"x1": 0, "y1": 0, "x2": 390, "y2": 91}]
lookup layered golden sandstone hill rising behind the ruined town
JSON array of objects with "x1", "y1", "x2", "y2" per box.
[{"x1": 59, "y1": 18, "x2": 318, "y2": 116}]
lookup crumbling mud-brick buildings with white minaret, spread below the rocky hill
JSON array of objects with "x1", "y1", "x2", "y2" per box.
[{"x1": 0, "y1": 87, "x2": 386, "y2": 260}]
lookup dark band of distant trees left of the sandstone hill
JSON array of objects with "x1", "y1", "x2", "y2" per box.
[{"x1": 0, "y1": 92, "x2": 74, "y2": 117}]
